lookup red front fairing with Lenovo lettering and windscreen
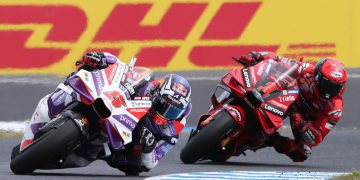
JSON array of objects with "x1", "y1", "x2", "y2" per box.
[{"x1": 222, "y1": 59, "x2": 299, "y2": 134}]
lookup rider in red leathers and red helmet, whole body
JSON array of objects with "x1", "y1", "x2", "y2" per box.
[{"x1": 235, "y1": 52, "x2": 347, "y2": 162}]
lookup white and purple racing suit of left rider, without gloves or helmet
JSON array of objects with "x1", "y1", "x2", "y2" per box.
[{"x1": 20, "y1": 75, "x2": 191, "y2": 173}]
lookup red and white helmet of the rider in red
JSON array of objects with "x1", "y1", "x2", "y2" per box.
[{"x1": 315, "y1": 58, "x2": 347, "y2": 100}]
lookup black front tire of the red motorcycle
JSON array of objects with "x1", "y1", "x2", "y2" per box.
[{"x1": 180, "y1": 110, "x2": 238, "y2": 164}]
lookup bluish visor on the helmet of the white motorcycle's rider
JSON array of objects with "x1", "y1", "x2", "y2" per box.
[{"x1": 154, "y1": 99, "x2": 185, "y2": 120}]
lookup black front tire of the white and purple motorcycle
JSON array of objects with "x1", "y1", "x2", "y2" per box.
[{"x1": 10, "y1": 119, "x2": 81, "y2": 174}]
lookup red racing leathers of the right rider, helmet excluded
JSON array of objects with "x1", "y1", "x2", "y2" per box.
[{"x1": 234, "y1": 52, "x2": 345, "y2": 162}]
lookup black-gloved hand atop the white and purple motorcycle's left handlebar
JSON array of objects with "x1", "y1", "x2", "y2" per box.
[{"x1": 76, "y1": 52, "x2": 109, "y2": 69}]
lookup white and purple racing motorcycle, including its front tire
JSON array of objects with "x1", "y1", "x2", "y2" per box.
[{"x1": 10, "y1": 58, "x2": 152, "y2": 174}]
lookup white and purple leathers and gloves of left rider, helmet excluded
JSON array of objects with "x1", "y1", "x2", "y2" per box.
[{"x1": 20, "y1": 52, "x2": 191, "y2": 175}]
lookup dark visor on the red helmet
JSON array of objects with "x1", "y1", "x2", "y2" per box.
[{"x1": 317, "y1": 76, "x2": 344, "y2": 99}]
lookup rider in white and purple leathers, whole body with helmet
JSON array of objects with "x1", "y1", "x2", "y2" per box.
[{"x1": 19, "y1": 52, "x2": 192, "y2": 175}]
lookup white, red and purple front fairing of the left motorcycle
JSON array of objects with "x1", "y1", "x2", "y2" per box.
[{"x1": 69, "y1": 61, "x2": 152, "y2": 149}]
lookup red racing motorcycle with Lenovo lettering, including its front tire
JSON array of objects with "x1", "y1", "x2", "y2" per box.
[{"x1": 180, "y1": 59, "x2": 299, "y2": 164}]
